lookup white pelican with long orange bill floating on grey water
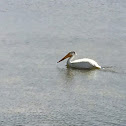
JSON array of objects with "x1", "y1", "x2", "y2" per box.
[{"x1": 57, "y1": 51, "x2": 101, "y2": 69}]
